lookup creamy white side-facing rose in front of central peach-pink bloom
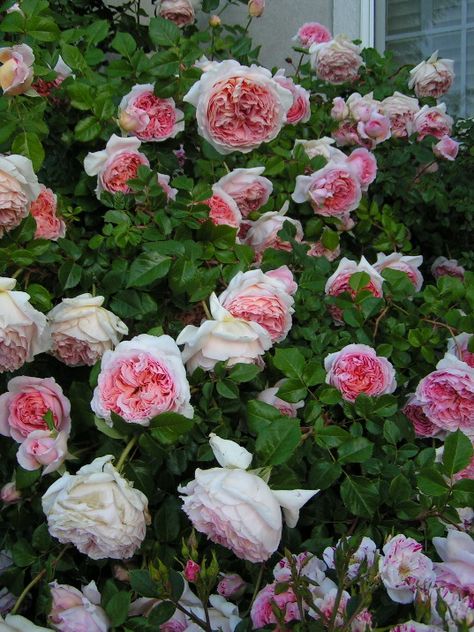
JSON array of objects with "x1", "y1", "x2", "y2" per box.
[{"x1": 176, "y1": 294, "x2": 272, "y2": 373}]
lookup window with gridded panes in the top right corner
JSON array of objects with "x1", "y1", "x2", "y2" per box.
[{"x1": 382, "y1": 0, "x2": 474, "y2": 116}]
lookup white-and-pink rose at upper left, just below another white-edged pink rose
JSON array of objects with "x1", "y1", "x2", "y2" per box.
[{"x1": 84, "y1": 134, "x2": 150, "y2": 199}]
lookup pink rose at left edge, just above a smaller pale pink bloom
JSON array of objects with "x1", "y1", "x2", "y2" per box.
[{"x1": 0, "y1": 375, "x2": 71, "y2": 443}]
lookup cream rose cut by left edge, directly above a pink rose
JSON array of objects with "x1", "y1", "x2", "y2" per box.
[{"x1": 0, "y1": 277, "x2": 51, "y2": 373}]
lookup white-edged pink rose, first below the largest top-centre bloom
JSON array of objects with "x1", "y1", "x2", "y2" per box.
[{"x1": 213, "y1": 167, "x2": 273, "y2": 217}]
